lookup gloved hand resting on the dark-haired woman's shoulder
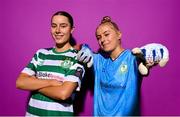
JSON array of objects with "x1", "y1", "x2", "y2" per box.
[{"x1": 77, "y1": 44, "x2": 93, "y2": 68}]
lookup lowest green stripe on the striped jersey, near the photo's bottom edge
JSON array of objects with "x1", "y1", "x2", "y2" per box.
[{"x1": 28, "y1": 106, "x2": 73, "y2": 116}]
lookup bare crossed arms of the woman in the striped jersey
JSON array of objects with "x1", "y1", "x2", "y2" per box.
[{"x1": 16, "y1": 73, "x2": 78, "y2": 100}]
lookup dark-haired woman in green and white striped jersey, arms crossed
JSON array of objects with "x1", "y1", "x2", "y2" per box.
[{"x1": 16, "y1": 11, "x2": 85, "y2": 116}]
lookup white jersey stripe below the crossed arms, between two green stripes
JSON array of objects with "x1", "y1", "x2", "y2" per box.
[{"x1": 29, "y1": 98, "x2": 73, "y2": 112}]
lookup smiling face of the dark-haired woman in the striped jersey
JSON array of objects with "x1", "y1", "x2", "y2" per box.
[{"x1": 51, "y1": 15, "x2": 73, "y2": 45}]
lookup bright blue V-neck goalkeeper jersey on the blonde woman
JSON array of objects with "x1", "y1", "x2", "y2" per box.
[{"x1": 94, "y1": 50, "x2": 141, "y2": 116}]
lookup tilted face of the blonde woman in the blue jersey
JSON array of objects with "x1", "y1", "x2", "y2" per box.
[{"x1": 96, "y1": 24, "x2": 121, "y2": 52}]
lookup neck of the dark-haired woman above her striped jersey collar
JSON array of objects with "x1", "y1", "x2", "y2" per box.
[{"x1": 55, "y1": 43, "x2": 72, "y2": 52}]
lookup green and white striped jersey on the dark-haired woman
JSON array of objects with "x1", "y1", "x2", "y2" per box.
[{"x1": 22, "y1": 48, "x2": 85, "y2": 116}]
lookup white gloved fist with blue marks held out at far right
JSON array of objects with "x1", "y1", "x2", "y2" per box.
[{"x1": 132, "y1": 43, "x2": 169, "y2": 75}]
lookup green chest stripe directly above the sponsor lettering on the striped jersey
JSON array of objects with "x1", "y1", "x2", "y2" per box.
[{"x1": 37, "y1": 65, "x2": 75, "y2": 76}]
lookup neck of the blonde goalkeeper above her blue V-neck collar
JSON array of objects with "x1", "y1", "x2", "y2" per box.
[{"x1": 110, "y1": 46, "x2": 124, "y2": 60}]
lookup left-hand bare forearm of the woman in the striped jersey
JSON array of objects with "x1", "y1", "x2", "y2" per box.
[{"x1": 16, "y1": 73, "x2": 54, "y2": 91}]
